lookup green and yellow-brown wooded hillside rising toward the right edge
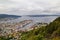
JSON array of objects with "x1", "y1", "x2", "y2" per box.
[{"x1": 21, "y1": 17, "x2": 60, "y2": 40}]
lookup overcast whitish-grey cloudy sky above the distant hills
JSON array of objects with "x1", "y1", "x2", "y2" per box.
[{"x1": 0, "y1": 0, "x2": 60, "y2": 15}]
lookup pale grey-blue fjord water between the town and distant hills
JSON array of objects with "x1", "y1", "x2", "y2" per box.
[{"x1": 1, "y1": 16, "x2": 59, "y2": 23}]
